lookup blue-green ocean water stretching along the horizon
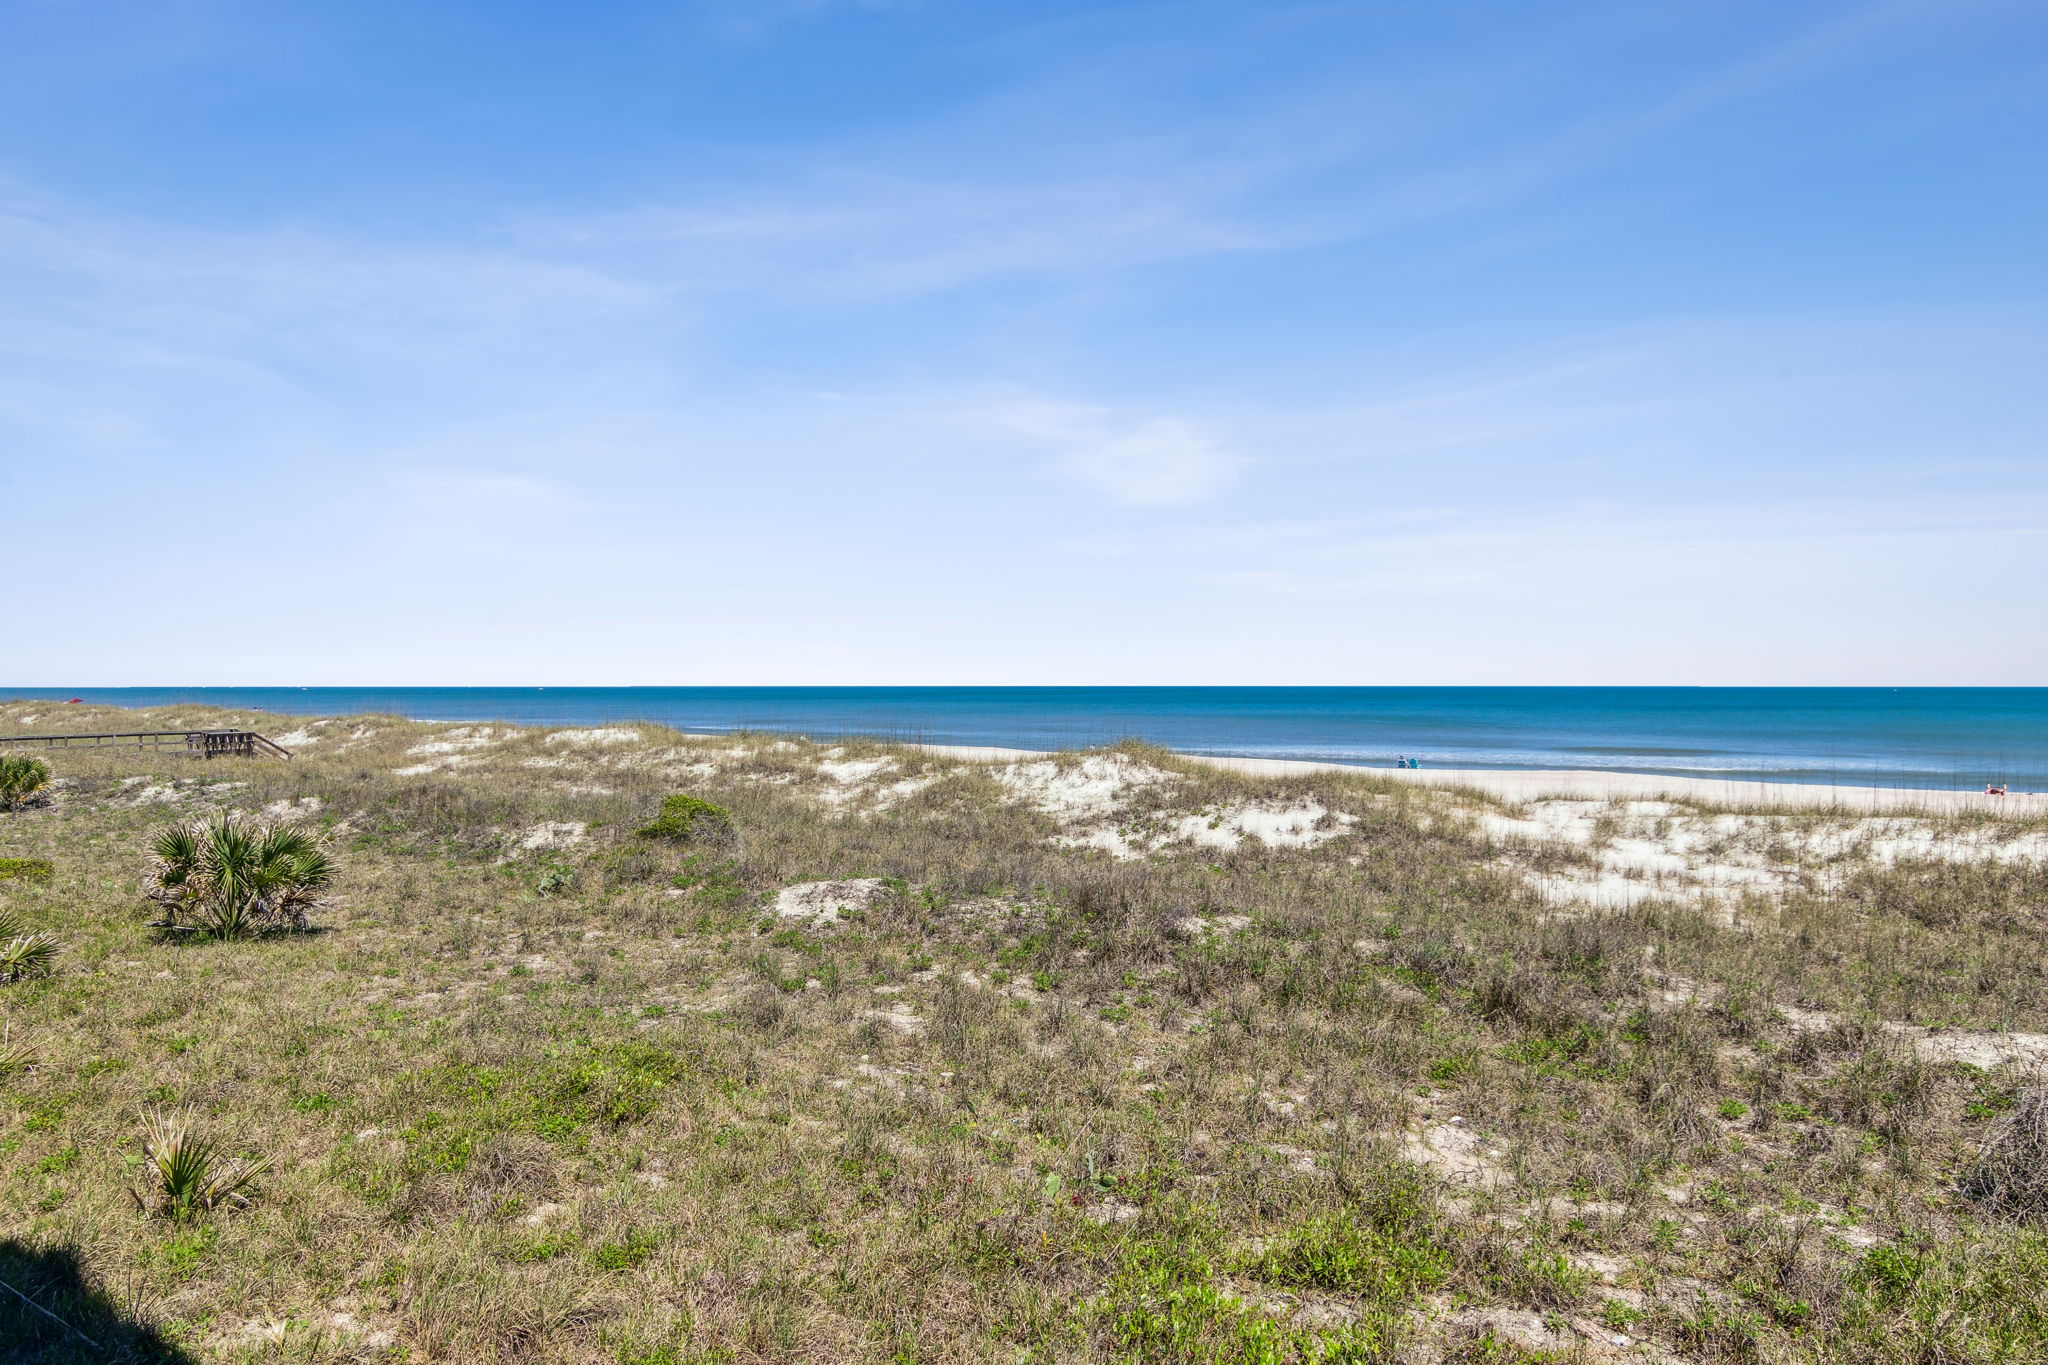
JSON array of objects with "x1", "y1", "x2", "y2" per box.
[{"x1": 0, "y1": 688, "x2": 2048, "y2": 790}]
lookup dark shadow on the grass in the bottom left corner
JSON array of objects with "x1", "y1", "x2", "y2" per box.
[{"x1": 0, "y1": 1238, "x2": 193, "y2": 1365}]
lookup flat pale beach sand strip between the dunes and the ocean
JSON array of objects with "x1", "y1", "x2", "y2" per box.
[{"x1": 920, "y1": 745, "x2": 2048, "y2": 819}]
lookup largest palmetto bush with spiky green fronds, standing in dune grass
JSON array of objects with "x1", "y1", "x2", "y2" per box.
[{"x1": 150, "y1": 814, "x2": 334, "y2": 939}]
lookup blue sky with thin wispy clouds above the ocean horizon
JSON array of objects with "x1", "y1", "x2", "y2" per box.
[{"x1": 0, "y1": 0, "x2": 2048, "y2": 686}]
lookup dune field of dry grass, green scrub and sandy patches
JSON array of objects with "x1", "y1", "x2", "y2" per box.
[{"x1": 0, "y1": 704, "x2": 2048, "y2": 1365}]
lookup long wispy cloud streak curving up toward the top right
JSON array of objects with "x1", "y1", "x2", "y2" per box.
[{"x1": 487, "y1": 0, "x2": 1974, "y2": 315}]
